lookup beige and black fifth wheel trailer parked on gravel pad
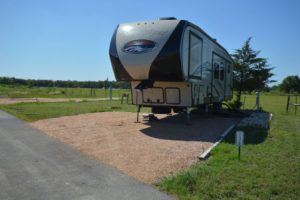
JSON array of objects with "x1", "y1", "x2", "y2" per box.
[{"x1": 109, "y1": 18, "x2": 232, "y2": 117}]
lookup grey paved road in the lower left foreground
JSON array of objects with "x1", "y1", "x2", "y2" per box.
[{"x1": 0, "y1": 111, "x2": 172, "y2": 200}]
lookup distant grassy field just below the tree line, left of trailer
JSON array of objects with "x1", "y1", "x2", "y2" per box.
[{"x1": 0, "y1": 84, "x2": 130, "y2": 98}]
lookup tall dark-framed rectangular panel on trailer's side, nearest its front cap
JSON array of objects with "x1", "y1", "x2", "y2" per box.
[{"x1": 189, "y1": 32, "x2": 202, "y2": 78}]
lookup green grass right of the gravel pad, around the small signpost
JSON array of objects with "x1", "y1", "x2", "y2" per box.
[{"x1": 159, "y1": 95, "x2": 300, "y2": 200}]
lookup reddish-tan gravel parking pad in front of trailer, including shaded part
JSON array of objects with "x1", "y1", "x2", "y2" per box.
[{"x1": 31, "y1": 112, "x2": 237, "y2": 183}]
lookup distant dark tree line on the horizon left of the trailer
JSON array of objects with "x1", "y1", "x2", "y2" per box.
[{"x1": 0, "y1": 77, "x2": 130, "y2": 89}]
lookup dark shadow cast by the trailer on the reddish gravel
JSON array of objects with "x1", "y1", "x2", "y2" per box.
[{"x1": 140, "y1": 113, "x2": 240, "y2": 142}]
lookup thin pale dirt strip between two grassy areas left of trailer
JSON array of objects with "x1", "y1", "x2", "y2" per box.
[{"x1": 0, "y1": 97, "x2": 120, "y2": 104}]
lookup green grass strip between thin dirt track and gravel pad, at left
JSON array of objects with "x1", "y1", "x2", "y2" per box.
[{"x1": 0, "y1": 101, "x2": 149, "y2": 122}]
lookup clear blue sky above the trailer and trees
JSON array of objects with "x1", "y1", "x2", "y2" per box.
[{"x1": 0, "y1": 0, "x2": 300, "y2": 82}]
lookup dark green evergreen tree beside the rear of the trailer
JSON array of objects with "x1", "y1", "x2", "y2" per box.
[{"x1": 231, "y1": 37, "x2": 274, "y2": 107}]
